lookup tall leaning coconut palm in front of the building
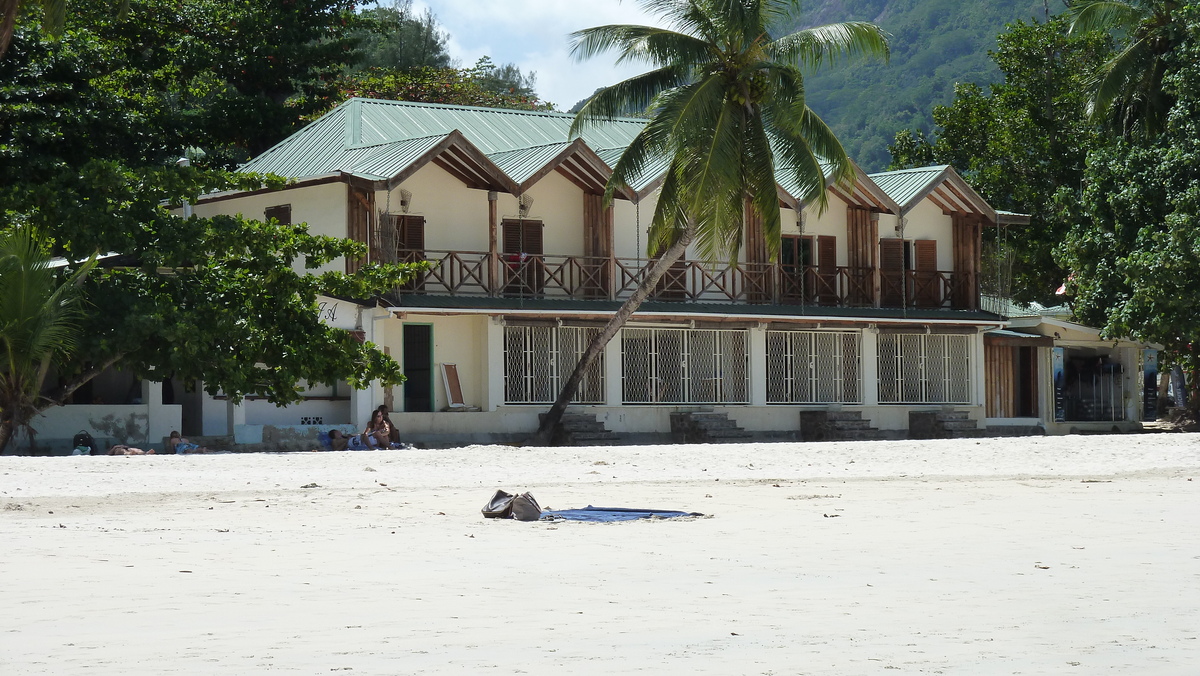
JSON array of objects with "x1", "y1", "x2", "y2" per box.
[{"x1": 535, "y1": 0, "x2": 888, "y2": 443}]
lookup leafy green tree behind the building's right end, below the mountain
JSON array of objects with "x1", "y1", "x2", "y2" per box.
[{"x1": 889, "y1": 18, "x2": 1109, "y2": 303}]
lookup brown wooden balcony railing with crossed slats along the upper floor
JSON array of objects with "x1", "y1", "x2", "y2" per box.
[{"x1": 396, "y1": 251, "x2": 978, "y2": 310}]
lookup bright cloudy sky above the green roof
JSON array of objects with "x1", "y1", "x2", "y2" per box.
[{"x1": 413, "y1": 0, "x2": 659, "y2": 110}]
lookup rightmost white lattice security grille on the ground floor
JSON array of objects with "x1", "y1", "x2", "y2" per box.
[{"x1": 880, "y1": 334, "x2": 971, "y2": 403}]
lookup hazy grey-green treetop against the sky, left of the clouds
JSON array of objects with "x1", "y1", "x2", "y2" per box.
[{"x1": 352, "y1": 0, "x2": 450, "y2": 71}]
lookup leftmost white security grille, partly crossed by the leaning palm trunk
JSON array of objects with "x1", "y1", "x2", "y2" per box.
[{"x1": 504, "y1": 327, "x2": 604, "y2": 403}]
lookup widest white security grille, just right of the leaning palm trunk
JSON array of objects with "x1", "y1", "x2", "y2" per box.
[{"x1": 622, "y1": 329, "x2": 750, "y2": 403}]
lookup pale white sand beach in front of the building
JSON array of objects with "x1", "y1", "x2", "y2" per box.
[{"x1": 0, "y1": 435, "x2": 1200, "y2": 676}]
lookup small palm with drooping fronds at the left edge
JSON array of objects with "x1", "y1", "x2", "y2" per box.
[{"x1": 0, "y1": 228, "x2": 96, "y2": 451}]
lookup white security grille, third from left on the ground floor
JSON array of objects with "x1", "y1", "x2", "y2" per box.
[{"x1": 767, "y1": 331, "x2": 863, "y2": 403}]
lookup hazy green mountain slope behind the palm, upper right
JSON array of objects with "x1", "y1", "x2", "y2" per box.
[{"x1": 781, "y1": 0, "x2": 1062, "y2": 172}]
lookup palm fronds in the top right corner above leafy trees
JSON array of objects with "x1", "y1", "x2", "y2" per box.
[{"x1": 1070, "y1": 0, "x2": 1186, "y2": 137}]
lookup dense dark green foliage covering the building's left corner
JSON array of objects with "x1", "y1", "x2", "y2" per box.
[{"x1": 0, "y1": 5, "x2": 420, "y2": 434}]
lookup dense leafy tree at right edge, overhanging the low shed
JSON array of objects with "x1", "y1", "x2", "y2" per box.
[{"x1": 1057, "y1": 4, "x2": 1200, "y2": 418}]
